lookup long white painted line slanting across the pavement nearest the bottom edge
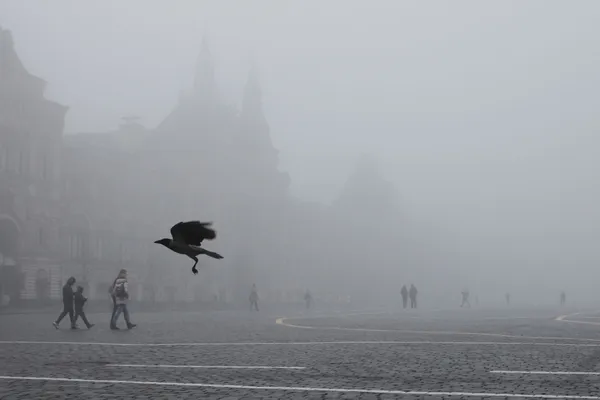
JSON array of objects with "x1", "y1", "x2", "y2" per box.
[{"x1": 0, "y1": 376, "x2": 600, "y2": 400}]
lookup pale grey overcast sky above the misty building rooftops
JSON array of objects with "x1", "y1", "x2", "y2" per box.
[{"x1": 0, "y1": 0, "x2": 600, "y2": 290}]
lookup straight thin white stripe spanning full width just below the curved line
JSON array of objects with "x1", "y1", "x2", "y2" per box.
[{"x1": 0, "y1": 338, "x2": 600, "y2": 347}]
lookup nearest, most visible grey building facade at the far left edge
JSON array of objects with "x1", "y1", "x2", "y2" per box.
[{"x1": 0, "y1": 28, "x2": 67, "y2": 304}]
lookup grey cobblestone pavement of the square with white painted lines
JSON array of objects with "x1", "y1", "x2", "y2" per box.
[{"x1": 0, "y1": 309, "x2": 600, "y2": 400}]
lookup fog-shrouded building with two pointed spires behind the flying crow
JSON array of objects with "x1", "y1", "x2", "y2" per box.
[{"x1": 62, "y1": 41, "x2": 289, "y2": 301}]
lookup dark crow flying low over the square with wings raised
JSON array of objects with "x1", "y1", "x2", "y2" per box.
[{"x1": 154, "y1": 221, "x2": 223, "y2": 274}]
